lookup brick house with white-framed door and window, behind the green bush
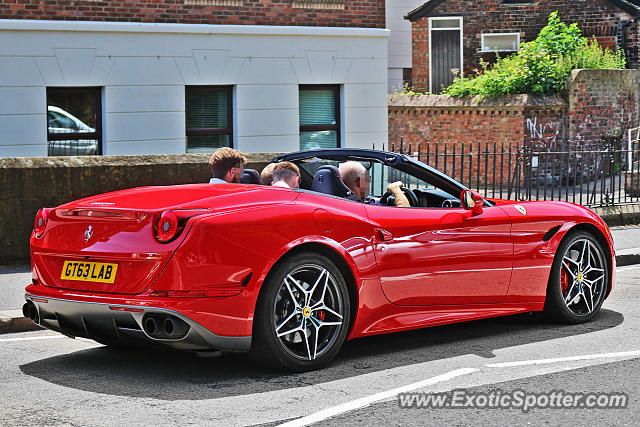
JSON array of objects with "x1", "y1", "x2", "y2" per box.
[{"x1": 406, "y1": 0, "x2": 640, "y2": 92}]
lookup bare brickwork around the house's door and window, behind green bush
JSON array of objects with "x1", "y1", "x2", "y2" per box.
[{"x1": 412, "y1": 0, "x2": 639, "y2": 92}]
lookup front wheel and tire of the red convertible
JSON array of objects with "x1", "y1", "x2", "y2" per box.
[{"x1": 544, "y1": 231, "x2": 611, "y2": 324}]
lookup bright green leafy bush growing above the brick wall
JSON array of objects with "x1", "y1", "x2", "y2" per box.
[{"x1": 443, "y1": 12, "x2": 626, "y2": 96}]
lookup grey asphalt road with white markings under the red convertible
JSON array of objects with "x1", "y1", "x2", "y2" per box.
[{"x1": 0, "y1": 266, "x2": 640, "y2": 425}]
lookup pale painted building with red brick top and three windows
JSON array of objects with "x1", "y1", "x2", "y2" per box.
[{"x1": 0, "y1": 0, "x2": 388, "y2": 157}]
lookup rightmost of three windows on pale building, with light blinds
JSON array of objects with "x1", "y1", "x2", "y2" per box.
[{"x1": 300, "y1": 85, "x2": 340, "y2": 150}]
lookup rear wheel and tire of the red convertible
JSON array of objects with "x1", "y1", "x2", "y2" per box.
[{"x1": 249, "y1": 252, "x2": 351, "y2": 372}]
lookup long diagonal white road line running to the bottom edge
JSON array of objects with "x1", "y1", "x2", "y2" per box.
[{"x1": 280, "y1": 368, "x2": 479, "y2": 427}]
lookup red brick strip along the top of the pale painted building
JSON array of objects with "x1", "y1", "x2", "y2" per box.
[{"x1": 0, "y1": 0, "x2": 385, "y2": 28}]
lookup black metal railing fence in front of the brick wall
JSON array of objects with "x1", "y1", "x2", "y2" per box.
[{"x1": 390, "y1": 139, "x2": 640, "y2": 207}]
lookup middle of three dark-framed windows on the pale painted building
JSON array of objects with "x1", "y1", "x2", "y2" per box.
[{"x1": 185, "y1": 86, "x2": 233, "y2": 153}]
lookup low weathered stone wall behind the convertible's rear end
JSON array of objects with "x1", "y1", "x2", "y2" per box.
[{"x1": 0, "y1": 153, "x2": 276, "y2": 262}]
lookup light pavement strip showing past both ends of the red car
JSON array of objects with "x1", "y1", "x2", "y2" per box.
[{"x1": 0, "y1": 225, "x2": 640, "y2": 334}]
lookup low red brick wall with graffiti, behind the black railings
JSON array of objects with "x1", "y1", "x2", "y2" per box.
[{"x1": 389, "y1": 94, "x2": 567, "y2": 186}]
